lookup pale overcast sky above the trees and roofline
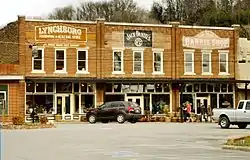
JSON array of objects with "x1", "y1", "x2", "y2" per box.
[{"x1": 0, "y1": 0, "x2": 153, "y2": 26}]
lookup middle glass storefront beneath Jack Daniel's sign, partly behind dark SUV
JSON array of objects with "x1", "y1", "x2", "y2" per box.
[{"x1": 105, "y1": 83, "x2": 172, "y2": 114}]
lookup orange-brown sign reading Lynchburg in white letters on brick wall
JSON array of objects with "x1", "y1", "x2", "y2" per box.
[{"x1": 35, "y1": 25, "x2": 87, "y2": 42}]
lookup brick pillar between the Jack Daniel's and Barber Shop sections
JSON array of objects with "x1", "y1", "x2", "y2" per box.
[{"x1": 169, "y1": 22, "x2": 180, "y2": 112}]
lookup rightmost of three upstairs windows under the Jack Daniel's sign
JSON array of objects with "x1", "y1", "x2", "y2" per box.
[{"x1": 153, "y1": 52, "x2": 163, "y2": 73}]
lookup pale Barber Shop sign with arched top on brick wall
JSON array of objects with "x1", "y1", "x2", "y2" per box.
[{"x1": 182, "y1": 31, "x2": 230, "y2": 49}]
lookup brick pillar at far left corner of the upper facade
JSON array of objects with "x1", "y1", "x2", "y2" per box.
[{"x1": 18, "y1": 16, "x2": 26, "y2": 75}]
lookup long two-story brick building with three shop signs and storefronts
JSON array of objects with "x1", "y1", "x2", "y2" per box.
[{"x1": 0, "y1": 16, "x2": 238, "y2": 120}]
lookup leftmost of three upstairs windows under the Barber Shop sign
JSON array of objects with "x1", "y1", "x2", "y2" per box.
[{"x1": 184, "y1": 51, "x2": 194, "y2": 74}]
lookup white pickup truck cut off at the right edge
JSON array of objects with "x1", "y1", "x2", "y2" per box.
[{"x1": 212, "y1": 100, "x2": 250, "y2": 129}]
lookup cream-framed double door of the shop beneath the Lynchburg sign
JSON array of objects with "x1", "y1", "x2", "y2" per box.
[{"x1": 56, "y1": 94, "x2": 73, "y2": 120}]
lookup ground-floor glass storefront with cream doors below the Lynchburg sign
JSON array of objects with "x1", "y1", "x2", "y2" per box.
[{"x1": 25, "y1": 81, "x2": 96, "y2": 120}]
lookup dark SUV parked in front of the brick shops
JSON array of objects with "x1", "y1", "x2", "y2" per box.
[{"x1": 86, "y1": 101, "x2": 142, "y2": 123}]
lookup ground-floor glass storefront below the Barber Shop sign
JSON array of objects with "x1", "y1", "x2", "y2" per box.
[{"x1": 180, "y1": 83, "x2": 235, "y2": 114}]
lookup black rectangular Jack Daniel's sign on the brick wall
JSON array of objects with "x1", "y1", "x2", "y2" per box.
[{"x1": 124, "y1": 30, "x2": 152, "y2": 47}]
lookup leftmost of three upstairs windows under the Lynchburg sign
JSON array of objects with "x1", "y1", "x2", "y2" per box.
[{"x1": 32, "y1": 49, "x2": 44, "y2": 72}]
